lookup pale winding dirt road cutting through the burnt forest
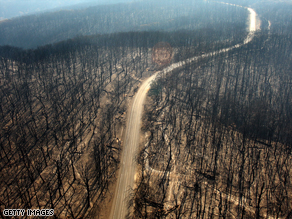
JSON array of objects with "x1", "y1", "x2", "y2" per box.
[{"x1": 110, "y1": 2, "x2": 257, "y2": 219}]
